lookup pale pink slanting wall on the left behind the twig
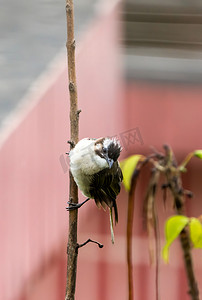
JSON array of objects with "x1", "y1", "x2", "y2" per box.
[{"x1": 0, "y1": 2, "x2": 126, "y2": 300}]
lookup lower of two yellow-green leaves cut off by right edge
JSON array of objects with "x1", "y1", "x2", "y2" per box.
[{"x1": 189, "y1": 218, "x2": 202, "y2": 248}]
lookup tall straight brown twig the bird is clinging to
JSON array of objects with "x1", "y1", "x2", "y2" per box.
[{"x1": 65, "y1": 0, "x2": 79, "y2": 300}]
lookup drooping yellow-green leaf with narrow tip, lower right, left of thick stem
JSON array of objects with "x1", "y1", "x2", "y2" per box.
[{"x1": 162, "y1": 216, "x2": 189, "y2": 263}]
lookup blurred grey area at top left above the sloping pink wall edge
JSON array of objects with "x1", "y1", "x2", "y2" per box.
[{"x1": 0, "y1": 0, "x2": 98, "y2": 126}]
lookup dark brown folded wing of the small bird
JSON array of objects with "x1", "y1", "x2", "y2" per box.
[{"x1": 90, "y1": 162, "x2": 123, "y2": 222}]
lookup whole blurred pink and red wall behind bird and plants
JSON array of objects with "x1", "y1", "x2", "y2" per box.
[{"x1": 0, "y1": 2, "x2": 202, "y2": 300}]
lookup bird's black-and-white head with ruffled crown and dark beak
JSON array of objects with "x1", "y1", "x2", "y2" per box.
[{"x1": 94, "y1": 138, "x2": 122, "y2": 169}]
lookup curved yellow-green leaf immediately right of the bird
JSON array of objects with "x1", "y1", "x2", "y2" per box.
[{"x1": 120, "y1": 154, "x2": 144, "y2": 191}]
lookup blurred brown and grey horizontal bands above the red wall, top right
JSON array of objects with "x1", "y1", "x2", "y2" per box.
[{"x1": 123, "y1": 0, "x2": 202, "y2": 83}]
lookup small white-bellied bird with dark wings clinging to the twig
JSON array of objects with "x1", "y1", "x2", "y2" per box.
[{"x1": 67, "y1": 137, "x2": 123, "y2": 243}]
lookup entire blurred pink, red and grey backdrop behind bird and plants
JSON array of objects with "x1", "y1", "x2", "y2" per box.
[{"x1": 0, "y1": 0, "x2": 202, "y2": 300}]
